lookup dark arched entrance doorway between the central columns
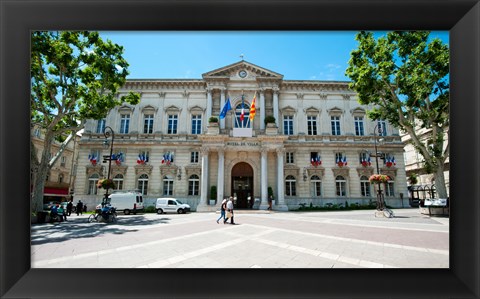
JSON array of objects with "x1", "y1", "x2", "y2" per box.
[{"x1": 232, "y1": 162, "x2": 254, "y2": 209}]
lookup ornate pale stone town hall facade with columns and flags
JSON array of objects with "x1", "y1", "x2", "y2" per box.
[{"x1": 75, "y1": 60, "x2": 408, "y2": 211}]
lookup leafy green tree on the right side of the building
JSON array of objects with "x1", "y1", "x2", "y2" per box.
[{"x1": 346, "y1": 31, "x2": 450, "y2": 198}]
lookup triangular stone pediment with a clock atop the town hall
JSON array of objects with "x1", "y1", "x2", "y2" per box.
[{"x1": 202, "y1": 60, "x2": 283, "y2": 79}]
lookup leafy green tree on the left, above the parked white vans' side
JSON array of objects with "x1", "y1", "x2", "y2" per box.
[{"x1": 30, "y1": 31, "x2": 140, "y2": 211}]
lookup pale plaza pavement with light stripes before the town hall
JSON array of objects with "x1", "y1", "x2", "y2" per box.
[{"x1": 31, "y1": 209, "x2": 449, "y2": 268}]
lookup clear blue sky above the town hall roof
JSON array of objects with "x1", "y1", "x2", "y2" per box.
[{"x1": 100, "y1": 31, "x2": 449, "y2": 81}]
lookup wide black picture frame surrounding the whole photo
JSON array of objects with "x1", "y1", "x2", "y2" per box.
[{"x1": 0, "y1": 0, "x2": 480, "y2": 298}]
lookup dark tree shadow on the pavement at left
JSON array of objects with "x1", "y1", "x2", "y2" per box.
[{"x1": 31, "y1": 215, "x2": 171, "y2": 245}]
